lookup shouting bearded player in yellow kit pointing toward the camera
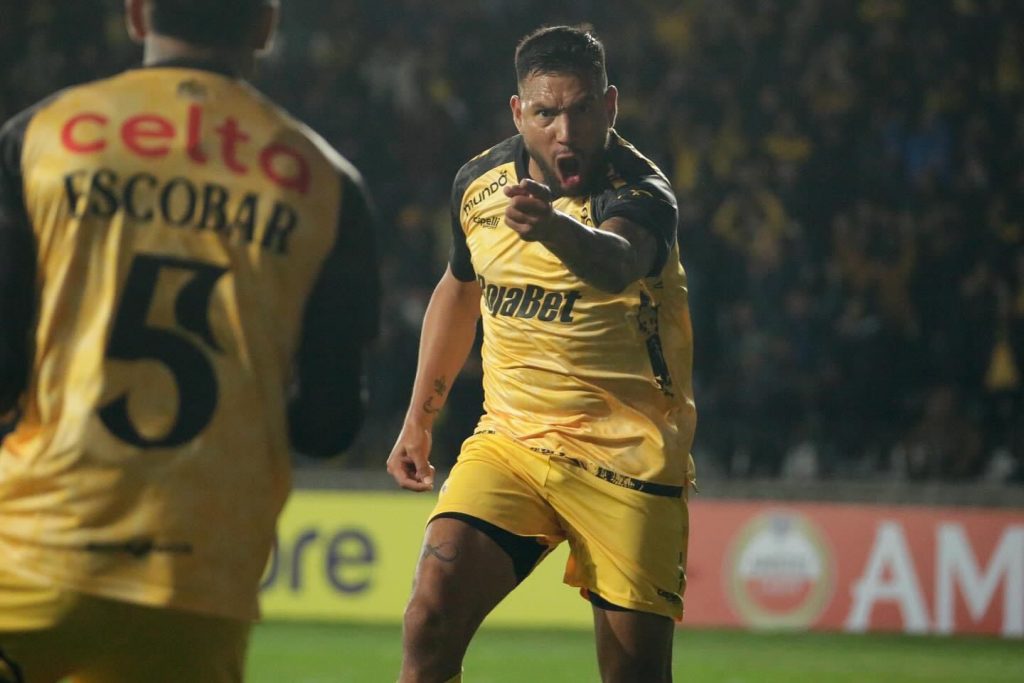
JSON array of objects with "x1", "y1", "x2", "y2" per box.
[{"x1": 387, "y1": 27, "x2": 695, "y2": 683}]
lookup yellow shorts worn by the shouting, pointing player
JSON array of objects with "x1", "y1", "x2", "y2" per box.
[{"x1": 431, "y1": 432, "x2": 689, "y2": 620}]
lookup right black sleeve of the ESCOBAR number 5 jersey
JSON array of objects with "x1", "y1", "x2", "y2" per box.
[{"x1": 289, "y1": 171, "x2": 380, "y2": 457}]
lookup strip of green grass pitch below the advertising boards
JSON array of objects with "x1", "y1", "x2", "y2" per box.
[{"x1": 247, "y1": 622, "x2": 1024, "y2": 683}]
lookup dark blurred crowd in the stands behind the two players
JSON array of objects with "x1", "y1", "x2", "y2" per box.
[{"x1": 0, "y1": 0, "x2": 1024, "y2": 481}]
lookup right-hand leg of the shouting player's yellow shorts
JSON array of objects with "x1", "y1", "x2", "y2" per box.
[{"x1": 550, "y1": 464, "x2": 689, "y2": 620}]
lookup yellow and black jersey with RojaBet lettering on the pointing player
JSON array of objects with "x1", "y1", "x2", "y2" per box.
[{"x1": 451, "y1": 132, "x2": 696, "y2": 496}]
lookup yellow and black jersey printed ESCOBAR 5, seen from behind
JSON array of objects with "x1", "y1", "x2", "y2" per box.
[{"x1": 0, "y1": 62, "x2": 378, "y2": 618}]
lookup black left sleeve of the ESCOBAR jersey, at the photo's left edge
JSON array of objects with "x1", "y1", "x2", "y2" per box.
[{"x1": 0, "y1": 110, "x2": 36, "y2": 417}]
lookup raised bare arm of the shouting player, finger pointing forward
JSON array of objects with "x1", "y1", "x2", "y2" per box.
[{"x1": 505, "y1": 180, "x2": 657, "y2": 294}]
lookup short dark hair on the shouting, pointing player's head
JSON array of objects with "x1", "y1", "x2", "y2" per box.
[{"x1": 515, "y1": 26, "x2": 608, "y2": 90}]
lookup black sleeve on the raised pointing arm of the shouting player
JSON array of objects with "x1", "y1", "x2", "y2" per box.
[{"x1": 594, "y1": 175, "x2": 679, "y2": 278}]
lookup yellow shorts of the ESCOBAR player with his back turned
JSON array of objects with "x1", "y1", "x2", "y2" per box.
[{"x1": 0, "y1": 567, "x2": 251, "y2": 683}]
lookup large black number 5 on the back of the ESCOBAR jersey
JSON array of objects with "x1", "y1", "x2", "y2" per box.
[{"x1": 99, "y1": 255, "x2": 227, "y2": 449}]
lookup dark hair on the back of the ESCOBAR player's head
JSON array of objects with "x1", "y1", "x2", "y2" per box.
[{"x1": 150, "y1": 0, "x2": 270, "y2": 47}]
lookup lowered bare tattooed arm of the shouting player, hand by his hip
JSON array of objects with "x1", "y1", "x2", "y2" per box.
[{"x1": 387, "y1": 268, "x2": 480, "y2": 490}]
